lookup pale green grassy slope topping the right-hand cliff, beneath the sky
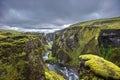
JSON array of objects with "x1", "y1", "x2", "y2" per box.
[{"x1": 70, "y1": 17, "x2": 120, "y2": 29}]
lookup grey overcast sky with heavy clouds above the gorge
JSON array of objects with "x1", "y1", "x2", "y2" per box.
[{"x1": 0, "y1": 0, "x2": 120, "y2": 31}]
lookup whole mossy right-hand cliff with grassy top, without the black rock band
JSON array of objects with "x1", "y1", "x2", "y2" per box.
[{"x1": 52, "y1": 17, "x2": 120, "y2": 65}]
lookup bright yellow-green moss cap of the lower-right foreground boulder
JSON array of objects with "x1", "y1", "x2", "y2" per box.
[{"x1": 79, "y1": 54, "x2": 120, "y2": 80}]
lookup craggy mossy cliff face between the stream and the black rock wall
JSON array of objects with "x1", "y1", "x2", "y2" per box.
[{"x1": 52, "y1": 26, "x2": 100, "y2": 65}]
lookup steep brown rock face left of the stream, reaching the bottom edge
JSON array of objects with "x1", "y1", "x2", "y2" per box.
[{"x1": 25, "y1": 39, "x2": 45, "y2": 80}]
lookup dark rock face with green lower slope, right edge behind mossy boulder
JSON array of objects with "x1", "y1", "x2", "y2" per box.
[{"x1": 98, "y1": 29, "x2": 120, "y2": 66}]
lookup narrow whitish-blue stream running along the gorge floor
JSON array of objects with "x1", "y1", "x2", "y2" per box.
[{"x1": 43, "y1": 51, "x2": 79, "y2": 80}]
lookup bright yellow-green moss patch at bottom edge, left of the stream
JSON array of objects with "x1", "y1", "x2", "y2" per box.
[{"x1": 45, "y1": 71, "x2": 66, "y2": 80}]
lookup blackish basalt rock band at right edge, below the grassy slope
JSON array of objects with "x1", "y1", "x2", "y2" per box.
[{"x1": 98, "y1": 29, "x2": 120, "y2": 47}]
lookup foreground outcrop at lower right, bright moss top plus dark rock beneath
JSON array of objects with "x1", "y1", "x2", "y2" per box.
[{"x1": 79, "y1": 54, "x2": 120, "y2": 80}]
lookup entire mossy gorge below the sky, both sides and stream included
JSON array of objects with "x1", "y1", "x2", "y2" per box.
[{"x1": 0, "y1": 17, "x2": 120, "y2": 80}]
